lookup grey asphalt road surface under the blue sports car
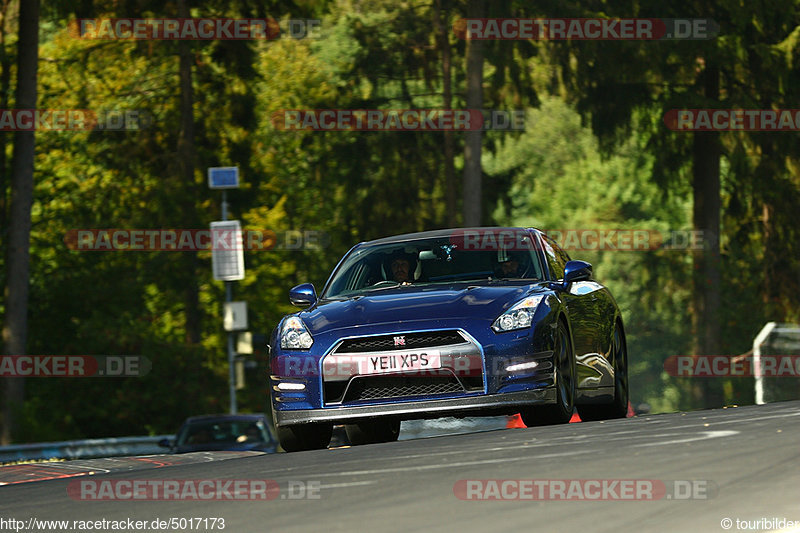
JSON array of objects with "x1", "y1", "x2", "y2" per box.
[{"x1": 0, "y1": 402, "x2": 800, "y2": 533}]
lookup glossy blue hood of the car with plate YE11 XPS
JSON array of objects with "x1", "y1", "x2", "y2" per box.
[{"x1": 299, "y1": 282, "x2": 543, "y2": 335}]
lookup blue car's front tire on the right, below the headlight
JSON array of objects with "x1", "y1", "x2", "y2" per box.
[{"x1": 520, "y1": 320, "x2": 575, "y2": 427}]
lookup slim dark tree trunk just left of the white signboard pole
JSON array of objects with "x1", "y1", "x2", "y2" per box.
[{"x1": 178, "y1": 0, "x2": 202, "y2": 344}]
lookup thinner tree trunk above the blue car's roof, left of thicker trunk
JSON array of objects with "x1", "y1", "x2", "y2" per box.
[{"x1": 434, "y1": 0, "x2": 458, "y2": 228}]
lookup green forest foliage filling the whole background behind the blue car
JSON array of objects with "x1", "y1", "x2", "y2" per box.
[{"x1": 0, "y1": 0, "x2": 800, "y2": 440}]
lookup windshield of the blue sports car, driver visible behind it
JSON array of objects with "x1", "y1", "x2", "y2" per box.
[{"x1": 323, "y1": 237, "x2": 543, "y2": 298}]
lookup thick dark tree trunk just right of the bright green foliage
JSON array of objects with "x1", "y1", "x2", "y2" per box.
[{"x1": 692, "y1": 65, "x2": 724, "y2": 407}]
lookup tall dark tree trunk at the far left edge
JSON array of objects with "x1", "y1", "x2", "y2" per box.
[{"x1": 0, "y1": 0, "x2": 39, "y2": 444}]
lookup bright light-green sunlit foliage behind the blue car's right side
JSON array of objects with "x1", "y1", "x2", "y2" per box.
[{"x1": 484, "y1": 97, "x2": 691, "y2": 411}]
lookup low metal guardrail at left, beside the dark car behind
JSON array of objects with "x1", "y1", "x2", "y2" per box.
[{"x1": 0, "y1": 435, "x2": 175, "y2": 463}]
